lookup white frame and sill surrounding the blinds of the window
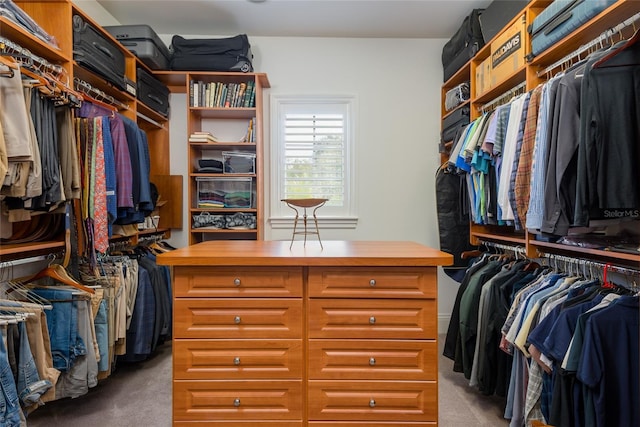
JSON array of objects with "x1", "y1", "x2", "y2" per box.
[{"x1": 269, "y1": 94, "x2": 358, "y2": 228}]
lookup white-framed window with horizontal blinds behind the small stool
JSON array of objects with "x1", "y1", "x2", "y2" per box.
[{"x1": 271, "y1": 96, "x2": 355, "y2": 227}]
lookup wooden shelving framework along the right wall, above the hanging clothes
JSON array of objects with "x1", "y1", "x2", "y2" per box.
[{"x1": 441, "y1": 0, "x2": 640, "y2": 267}]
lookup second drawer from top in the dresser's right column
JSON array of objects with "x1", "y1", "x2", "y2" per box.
[{"x1": 309, "y1": 299, "x2": 438, "y2": 339}]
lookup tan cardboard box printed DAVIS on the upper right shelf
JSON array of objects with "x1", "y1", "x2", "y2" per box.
[{"x1": 490, "y1": 14, "x2": 527, "y2": 87}]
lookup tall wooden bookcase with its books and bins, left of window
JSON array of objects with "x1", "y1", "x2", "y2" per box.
[{"x1": 185, "y1": 73, "x2": 269, "y2": 244}]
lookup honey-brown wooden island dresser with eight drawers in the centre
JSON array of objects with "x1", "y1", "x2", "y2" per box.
[{"x1": 158, "y1": 240, "x2": 452, "y2": 427}]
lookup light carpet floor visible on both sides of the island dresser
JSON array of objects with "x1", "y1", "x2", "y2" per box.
[{"x1": 27, "y1": 335, "x2": 509, "y2": 427}]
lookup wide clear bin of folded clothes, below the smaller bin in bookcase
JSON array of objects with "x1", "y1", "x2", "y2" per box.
[{"x1": 196, "y1": 177, "x2": 253, "y2": 209}]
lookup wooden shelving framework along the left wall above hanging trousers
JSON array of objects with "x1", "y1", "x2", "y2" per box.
[{"x1": 0, "y1": 0, "x2": 182, "y2": 261}]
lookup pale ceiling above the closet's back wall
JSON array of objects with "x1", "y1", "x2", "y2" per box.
[{"x1": 96, "y1": 0, "x2": 491, "y2": 39}]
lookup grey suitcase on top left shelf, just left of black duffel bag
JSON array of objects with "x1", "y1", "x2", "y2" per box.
[{"x1": 103, "y1": 25, "x2": 170, "y2": 70}]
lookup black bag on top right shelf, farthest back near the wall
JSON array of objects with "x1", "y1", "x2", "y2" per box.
[{"x1": 442, "y1": 9, "x2": 484, "y2": 82}]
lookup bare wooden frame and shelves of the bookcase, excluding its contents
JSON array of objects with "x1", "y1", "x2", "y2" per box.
[{"x1": 175, "y1": 72, "x2": 269, "y2": 244}]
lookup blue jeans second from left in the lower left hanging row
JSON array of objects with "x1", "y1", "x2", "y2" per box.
[{"x1": 16, "y1": 322, "x2": 52, "y2": 406}]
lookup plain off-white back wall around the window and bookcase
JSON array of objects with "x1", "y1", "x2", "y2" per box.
[{"x1": 76, "y1": 1, "x2": 458, "y2": 332}]
